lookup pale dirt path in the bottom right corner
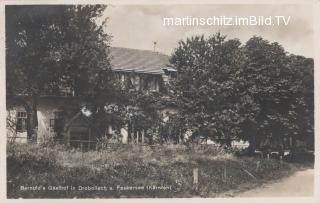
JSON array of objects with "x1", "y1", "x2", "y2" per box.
[{"x1": 235, "y1": 169, "x2": 314, "y2": 197}]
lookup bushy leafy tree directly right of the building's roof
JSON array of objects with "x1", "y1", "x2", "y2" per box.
[{"x1": 170, "y1": 33, "x2": 256, "y2": 145}]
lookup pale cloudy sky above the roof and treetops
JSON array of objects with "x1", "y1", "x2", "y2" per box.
[{"x1": 102, "y1": 4, "x2": 314, "y2": 57}]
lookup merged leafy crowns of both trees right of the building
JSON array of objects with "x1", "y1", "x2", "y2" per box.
[{"x1": 170, "y1": 33, "x2": 313, "y2": 147}]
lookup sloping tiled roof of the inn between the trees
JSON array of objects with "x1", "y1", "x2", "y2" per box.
[{"x1": 110, "y1": 47, "x2": 169, "y2": 74}]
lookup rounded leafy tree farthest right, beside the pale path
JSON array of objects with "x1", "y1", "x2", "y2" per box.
[{"x1": 240, "y1": 37, "x2": 313, "y2": 149}]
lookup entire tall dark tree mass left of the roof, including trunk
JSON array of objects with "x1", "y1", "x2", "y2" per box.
[{"x1": 6, "y1": 5, "x2": 114, "y2": 141}]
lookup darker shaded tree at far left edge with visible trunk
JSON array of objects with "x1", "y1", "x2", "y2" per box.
[{"x1": 6, "y1": 6, "x2": 67, "y2": 138}]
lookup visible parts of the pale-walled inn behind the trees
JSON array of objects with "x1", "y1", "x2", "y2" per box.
[{"x1": 7, "y1": 47, "x2": 176, "y2": 146}]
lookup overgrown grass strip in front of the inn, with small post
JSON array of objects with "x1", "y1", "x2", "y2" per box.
[{"x1": 7, "y1": 145, "x2": 310, "y2": 198}]
